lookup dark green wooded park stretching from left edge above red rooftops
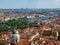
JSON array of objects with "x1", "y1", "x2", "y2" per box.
[{"x1": 0, "y1": 18, "x2": 34, "y2": 33}]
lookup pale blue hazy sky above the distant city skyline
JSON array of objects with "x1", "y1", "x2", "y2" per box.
[{"x1": 0, "y1": 0, "x2": 60, "y2": 9}]
